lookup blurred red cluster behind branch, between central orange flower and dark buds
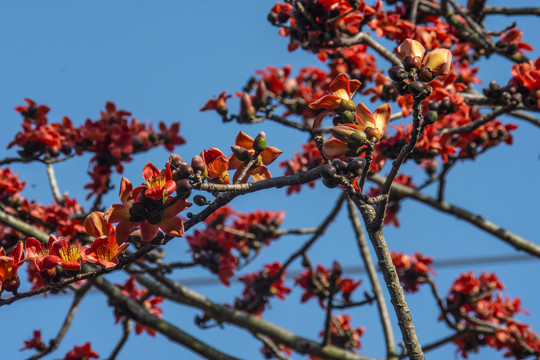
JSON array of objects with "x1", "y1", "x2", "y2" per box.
[{"x1": 279, "y1": 141, "x2": 324, "y2": 195}]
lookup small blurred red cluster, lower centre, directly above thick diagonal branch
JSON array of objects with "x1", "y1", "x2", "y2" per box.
[{"x1": 234, "y1": 262, "x2": 291, "y2": 316}]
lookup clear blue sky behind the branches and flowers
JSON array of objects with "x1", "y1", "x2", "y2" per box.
[{"x1": 0, "y1": 1, "x2": 540, "y2": 359}]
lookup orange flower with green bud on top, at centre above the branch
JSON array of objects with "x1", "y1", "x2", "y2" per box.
[{"x1": 229, "y1": 131, "x2": 283, "y2": 183}]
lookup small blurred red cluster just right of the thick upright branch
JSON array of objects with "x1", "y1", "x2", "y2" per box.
[{"x1": 391, "y1": 252, "x2": 435, "y2": 292}]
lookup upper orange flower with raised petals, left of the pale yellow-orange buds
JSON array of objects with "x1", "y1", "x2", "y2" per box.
[{"x1": 309, "y1": 73, "x2": 361, "y2": 129}]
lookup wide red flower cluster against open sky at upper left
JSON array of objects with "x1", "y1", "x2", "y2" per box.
[{"x1": 8, "y1": 99, "x2": 185, "y2": 197}]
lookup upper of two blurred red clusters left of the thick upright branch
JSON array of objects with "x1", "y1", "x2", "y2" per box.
[{"x1": 294, "y1": 262, "x2": 362, "y2": 309}]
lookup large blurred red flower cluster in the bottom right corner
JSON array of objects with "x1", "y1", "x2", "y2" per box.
[{"x1": 446, "y1": 272, "x2": 540, "y2": 359}]
